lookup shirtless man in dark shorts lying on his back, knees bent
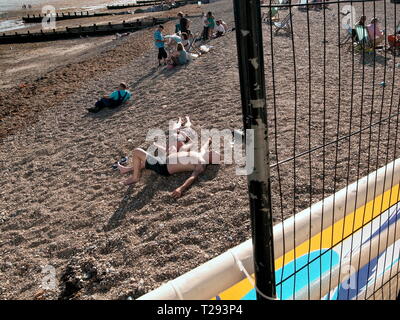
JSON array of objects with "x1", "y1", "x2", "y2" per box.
[{"x1": 119, "y1": 138, "x2": 220, "y2": 198}]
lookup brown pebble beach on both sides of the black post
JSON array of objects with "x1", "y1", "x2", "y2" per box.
[{"x1": 0, "y1": 0, "x2": 400, "y2": 300}]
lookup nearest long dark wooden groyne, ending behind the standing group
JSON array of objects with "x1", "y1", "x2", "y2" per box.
[{"x1": 0, "y1": 17, "x2": 177, "y2": 44}]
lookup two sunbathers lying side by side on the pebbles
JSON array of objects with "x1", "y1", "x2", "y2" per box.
[{"x1": 118, "y1": 117, "x2": 221, "y2": 198}]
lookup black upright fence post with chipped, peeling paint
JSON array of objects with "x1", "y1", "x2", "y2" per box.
[{"x1": 233, "y1": 0, "x2": 276, "y2": 300}]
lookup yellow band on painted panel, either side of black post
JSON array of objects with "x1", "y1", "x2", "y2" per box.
[{"x1": 219, "y1": 184, "x2": 400, "y2": 300}]
